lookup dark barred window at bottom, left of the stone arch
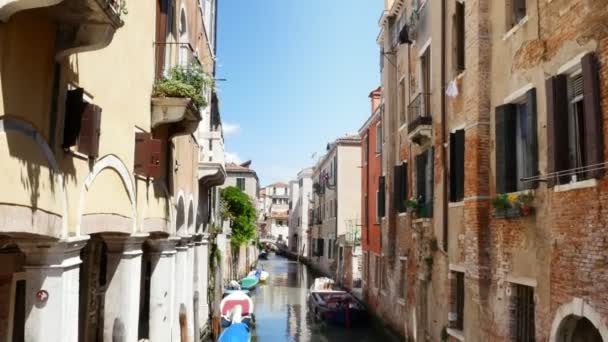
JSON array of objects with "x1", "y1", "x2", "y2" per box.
[{"x1": 510, "y1": 284, "x2": 535, "y2": 342}]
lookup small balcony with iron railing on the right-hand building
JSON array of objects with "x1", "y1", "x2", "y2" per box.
[{"x1": 407, "y1": 93, "x2": 433, "y2": 145}]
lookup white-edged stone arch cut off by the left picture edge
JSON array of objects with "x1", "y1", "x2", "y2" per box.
[{"x1": 0, "y1": 116, "x2": 68, "y2": 238}]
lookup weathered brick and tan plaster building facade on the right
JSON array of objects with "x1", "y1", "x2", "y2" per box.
[{"x1": 377, "y1": 0, "x2": 608, "y2": 341}]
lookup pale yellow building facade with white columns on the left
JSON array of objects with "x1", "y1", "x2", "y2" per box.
[{"x1": 0, "y1": 0, "x2": 223, "y2": 341}]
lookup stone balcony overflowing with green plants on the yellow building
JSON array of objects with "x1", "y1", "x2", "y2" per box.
[{"x1": 152, "y1": 43, "x2": 203, "y2": 136}]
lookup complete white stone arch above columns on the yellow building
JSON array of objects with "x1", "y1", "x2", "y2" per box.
[{"x1": 76, "y1": 154, "x2": 137, "y2": 234}]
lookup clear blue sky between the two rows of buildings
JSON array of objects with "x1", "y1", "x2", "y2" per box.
[{"x1": 217, "y1": 0, "x2": 383, "y2": 185}]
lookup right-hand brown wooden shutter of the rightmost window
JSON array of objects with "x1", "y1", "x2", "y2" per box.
[{"x1": 581, "y1": 53, "x2": 604, "y2": 178}]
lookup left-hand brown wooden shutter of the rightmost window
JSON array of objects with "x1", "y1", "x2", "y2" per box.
[{"x1": 545, "y1": 75, "x2": 570, "y2": 187}]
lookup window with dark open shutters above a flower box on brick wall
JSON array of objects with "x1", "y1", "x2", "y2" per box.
[{"x1": 496, "y1": 89, "x2": 538, "y2": 193}]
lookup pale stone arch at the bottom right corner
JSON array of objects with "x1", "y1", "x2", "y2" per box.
[{"x1": 549, "y1": 298, "x2": 608, "y2": 342}]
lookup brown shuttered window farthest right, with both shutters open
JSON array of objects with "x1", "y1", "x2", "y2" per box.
[{"x1": 546, "y1": 53, "x2": 604, "y2": 186}]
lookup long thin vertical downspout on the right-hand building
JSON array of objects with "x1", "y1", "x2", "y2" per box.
[{"x1": 441, "y1": 0, "x2": 448, "y2": 253}]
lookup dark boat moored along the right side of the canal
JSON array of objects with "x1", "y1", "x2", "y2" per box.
[{"x1": 308, "y1": 278, "x2": 367, "y2": 327}]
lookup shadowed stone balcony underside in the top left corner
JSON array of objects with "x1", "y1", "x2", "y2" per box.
[{"x1": 0, "y1": 0, "x2": 126, "y2": 60}]
